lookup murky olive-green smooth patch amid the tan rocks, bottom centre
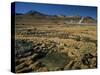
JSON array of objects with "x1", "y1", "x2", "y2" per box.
[{"x1": 39, "y1": 52, "x2": 69, "y2": 70}]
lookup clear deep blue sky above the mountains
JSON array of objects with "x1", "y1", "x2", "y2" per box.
[{"x1": 15, "y1": 2, "x2": 97, "y2": 19}]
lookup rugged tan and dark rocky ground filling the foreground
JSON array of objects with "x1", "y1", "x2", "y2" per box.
[{"x1": 15, "y1": 38, "x2": 97, "y2": 73}]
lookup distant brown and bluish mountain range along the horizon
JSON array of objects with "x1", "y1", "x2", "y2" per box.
[{"x1": 15, "y1": 10, "x2": 97, "y2": 24}]
